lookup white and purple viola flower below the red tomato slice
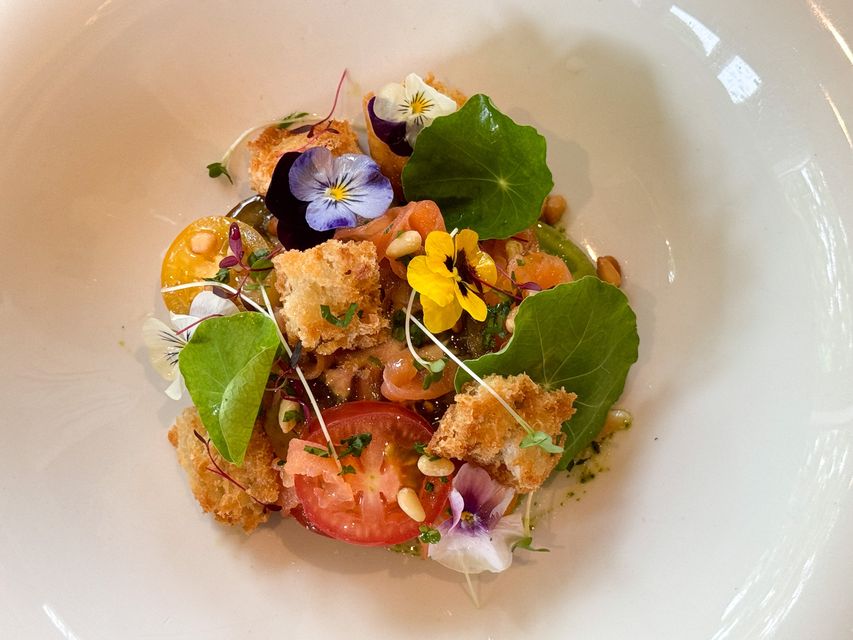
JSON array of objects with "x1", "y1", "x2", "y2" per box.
[{"x1": 428, "y1": 463, "x2": 525, "y2": 574}]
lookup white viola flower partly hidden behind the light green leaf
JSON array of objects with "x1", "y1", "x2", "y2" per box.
[{"x1": 142, "y1": 291, "x2": 239, "y2": 400}]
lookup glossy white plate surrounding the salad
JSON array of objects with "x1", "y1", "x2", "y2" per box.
[{"x1": 0, "y1": 0, "x2": 853, "y2": 640}]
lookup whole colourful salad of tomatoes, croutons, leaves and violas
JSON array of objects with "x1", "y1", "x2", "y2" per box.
[{"x1": 143, "y1": 74, "x2": 639, "y2": 596}]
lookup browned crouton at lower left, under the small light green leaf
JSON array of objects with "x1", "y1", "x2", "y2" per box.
[{"x1": 169, "y1": 407, "x2": 282, "y2": 533}]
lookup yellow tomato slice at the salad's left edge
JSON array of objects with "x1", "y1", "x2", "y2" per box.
[{"x1": 160, "y1": 216, "x2": 278, "y2": 314}]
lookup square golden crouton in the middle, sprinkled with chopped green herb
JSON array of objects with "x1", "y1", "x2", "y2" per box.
[{"x1": 273, "y1": 240, "x2": 390, "y2": 355}]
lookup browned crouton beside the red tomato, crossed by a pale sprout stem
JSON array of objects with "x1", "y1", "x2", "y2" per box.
[{"x1": 427, "y1": 374, "x2": 577, "y2": 493}]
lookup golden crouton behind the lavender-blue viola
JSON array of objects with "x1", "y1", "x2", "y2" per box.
[{"x1": 248, "y1": 120, "x2": 361, "y2": 196}]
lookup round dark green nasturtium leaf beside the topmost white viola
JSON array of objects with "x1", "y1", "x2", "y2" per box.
[{"x1": 402, "y1": 94, "x2": 554, "y2": 240}]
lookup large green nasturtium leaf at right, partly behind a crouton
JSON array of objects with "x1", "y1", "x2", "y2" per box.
[{"x1": 456, "y1": 276, "x2": 640, "y2": 468}]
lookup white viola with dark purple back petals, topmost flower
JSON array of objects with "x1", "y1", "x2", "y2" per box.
[{"x1": 368, "y1": 73, "x2": 456, "y2": 149}]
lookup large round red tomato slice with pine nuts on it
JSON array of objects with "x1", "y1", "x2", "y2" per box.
[{"x1": 286, "y1": 402, "x2": 451, "y2": 545}]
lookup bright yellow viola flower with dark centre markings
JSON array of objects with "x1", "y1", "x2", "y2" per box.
[{"x1": 406, "y1": 229, "x2": 498, "y2": 333}]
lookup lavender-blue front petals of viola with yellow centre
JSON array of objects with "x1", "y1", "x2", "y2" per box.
[{"x1": 289, "y1": 147, "x2": 394, "y2": 231}]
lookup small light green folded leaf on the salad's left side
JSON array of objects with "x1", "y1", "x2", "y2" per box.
[{"x1": 178, "y1": 312, "x2": 279, "y2": 465}]
